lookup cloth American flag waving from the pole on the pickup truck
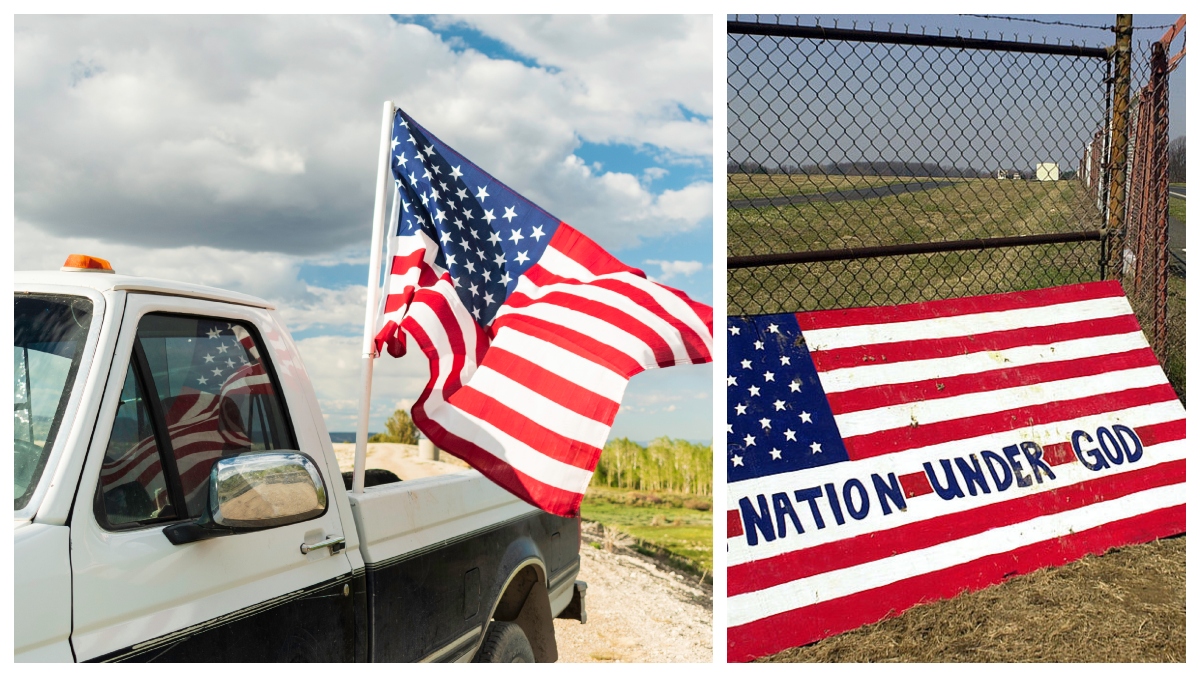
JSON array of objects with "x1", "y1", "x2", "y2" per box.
[{"x1": 376, "y1": 112, "x2": 713, "y2": 516}]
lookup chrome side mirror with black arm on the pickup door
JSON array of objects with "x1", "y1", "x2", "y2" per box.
[{"x1": 162, "y1": 451, "x2": 329, "y2": 545}]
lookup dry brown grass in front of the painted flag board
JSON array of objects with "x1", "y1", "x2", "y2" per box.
[{"x1": 762, "y1": 535, "x2": 1187, "y2": 663}]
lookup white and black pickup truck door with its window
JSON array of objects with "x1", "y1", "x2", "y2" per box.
[{"x1": 71, "y1": 294, "x2": 354, "y2": 661}]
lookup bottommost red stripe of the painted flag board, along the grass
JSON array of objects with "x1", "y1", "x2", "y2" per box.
[{"x1": 727, "y1": 505, "x2": 1186, "y2": 663}]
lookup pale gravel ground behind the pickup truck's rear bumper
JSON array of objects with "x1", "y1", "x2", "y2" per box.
[{"x1": 554, "y1": 522, "x2": 713, "y2": 663}]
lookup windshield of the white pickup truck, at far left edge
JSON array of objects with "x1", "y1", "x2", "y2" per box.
[{"x1": 12, "y1": 294, "x2": 92, "y2": 510}]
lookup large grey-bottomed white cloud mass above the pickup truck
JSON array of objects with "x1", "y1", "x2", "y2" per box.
[{"x1": 14, "y1": 16, "x2": 713, "y2": 260}]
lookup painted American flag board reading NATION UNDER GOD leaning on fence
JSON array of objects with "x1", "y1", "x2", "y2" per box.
[{"x1": 726, "y1": 282, "x2": 1186, "y2": 660}]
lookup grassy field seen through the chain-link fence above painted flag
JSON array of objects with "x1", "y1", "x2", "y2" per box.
[{"x1": 728, "y1": 175, "x2": 1099, "y2": 314}]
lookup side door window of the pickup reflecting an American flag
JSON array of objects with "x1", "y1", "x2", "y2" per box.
[{"x1": 95, "y1": 313, "x2": 296, "y2": 526}]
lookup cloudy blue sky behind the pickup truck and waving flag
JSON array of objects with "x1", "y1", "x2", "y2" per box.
[{"x1": 14, "y1": 16, "x2": 713, "y2": 441}]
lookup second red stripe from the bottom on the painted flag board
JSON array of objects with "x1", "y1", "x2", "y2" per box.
[{"x1": 727, "y1": 460, "x2": 1184, "y2": 597}]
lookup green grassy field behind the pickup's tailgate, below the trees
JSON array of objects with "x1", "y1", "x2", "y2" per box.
[{"x1": 582, "y1": 486, "x2": 713, "y2": 576}]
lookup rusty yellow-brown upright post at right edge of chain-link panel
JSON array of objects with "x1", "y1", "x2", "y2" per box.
[{"x1": 1106, "y1": 14, "x2": 1133, "y2": 278}]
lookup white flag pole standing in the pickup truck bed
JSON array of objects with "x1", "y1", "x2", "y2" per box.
[{"x1": 352, "y1": 101, "x2": 396, "y2": 495}]
